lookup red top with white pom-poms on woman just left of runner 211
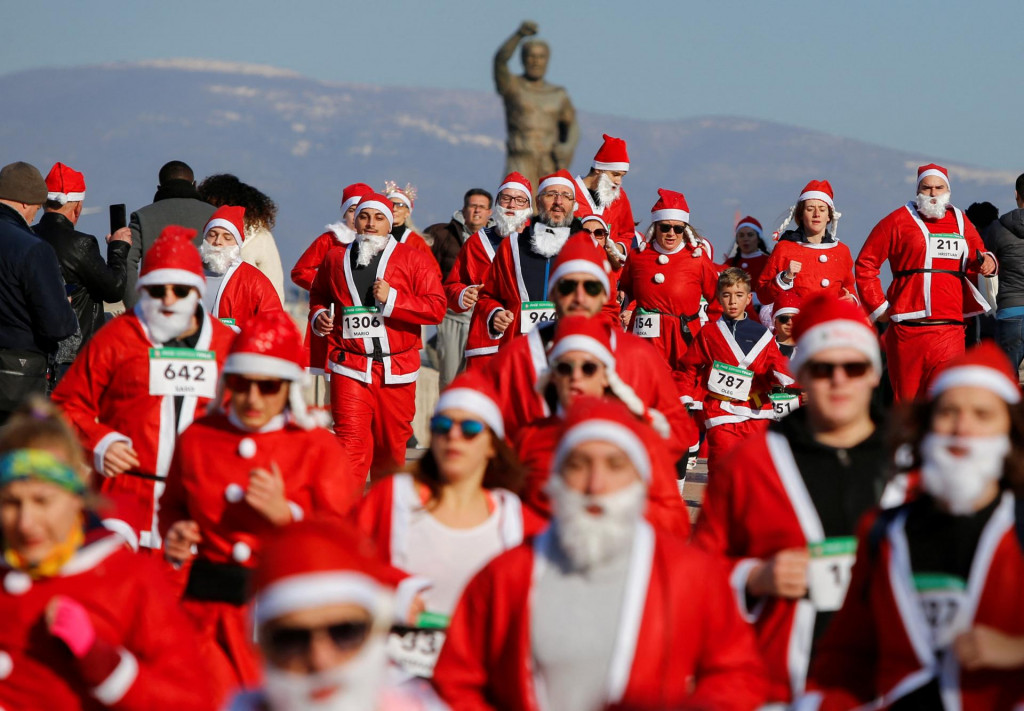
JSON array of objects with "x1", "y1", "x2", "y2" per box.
[{"x1": 756, "y1": 240, "x2": 856, "y2": 305}]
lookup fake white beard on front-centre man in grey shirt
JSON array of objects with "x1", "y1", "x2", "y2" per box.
[{"x1": 547, "y1": 473, "x2": 647, "y2": 571}]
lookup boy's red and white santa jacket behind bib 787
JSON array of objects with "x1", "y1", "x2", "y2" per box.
[{"x1": 681, "y1": 320, "x2": 795, "y2": 427}]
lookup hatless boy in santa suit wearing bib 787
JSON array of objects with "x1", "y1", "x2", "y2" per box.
[{"x1": 681, "y1": 266, "x2": 797, "y2": 476}]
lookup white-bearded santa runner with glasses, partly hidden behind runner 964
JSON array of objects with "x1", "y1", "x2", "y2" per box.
[{"x1": 444, "y1": 173, "x2": 534, "y2": 369}]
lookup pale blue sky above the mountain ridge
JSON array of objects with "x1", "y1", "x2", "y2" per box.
[{"x1": 6, "y1": 0, "x2": 1024, "y2": 171}]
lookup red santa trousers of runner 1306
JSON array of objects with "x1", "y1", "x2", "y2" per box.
[{"x1": 331, "y1": 362, "x2": 416, "y2": 478}]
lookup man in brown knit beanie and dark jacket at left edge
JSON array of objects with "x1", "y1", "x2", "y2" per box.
[{"x1": 0, "y1": 162, "x2": 78, "y2": 424}]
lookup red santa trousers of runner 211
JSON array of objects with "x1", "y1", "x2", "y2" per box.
[{"x1": 882, "y1": 323, "x2": 964, "y2": 403}]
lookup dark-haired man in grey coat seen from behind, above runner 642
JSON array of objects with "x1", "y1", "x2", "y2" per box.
[{"x1": 124, "y1": 161, "x2": 216, "y2": 308}]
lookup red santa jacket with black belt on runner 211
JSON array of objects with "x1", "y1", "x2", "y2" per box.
[{"x1": 856, "y1": 203, "x2": 995, "y2": 322}]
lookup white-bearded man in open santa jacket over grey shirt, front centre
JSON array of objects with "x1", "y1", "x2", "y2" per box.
[{"x1": 433, "y1": 398, "x2": 765, "y2": 711}]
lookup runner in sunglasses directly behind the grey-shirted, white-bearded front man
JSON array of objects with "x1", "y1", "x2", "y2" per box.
[{"x1": 513, "y1": 316, "x2": 696, "y2": 540}]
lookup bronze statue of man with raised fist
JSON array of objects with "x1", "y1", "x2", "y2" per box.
[{"x1": 495, "y1": 20, "x2": 580, "y2": 190}]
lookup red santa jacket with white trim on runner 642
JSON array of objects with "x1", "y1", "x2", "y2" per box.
[{"x1": 53, "y1": 306, "x2": 234, "y2": 548}]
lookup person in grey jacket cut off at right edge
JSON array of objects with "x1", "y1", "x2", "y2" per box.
[{"x1": 979, "y1": 173, "x2": 1024, "y2": 369}]
